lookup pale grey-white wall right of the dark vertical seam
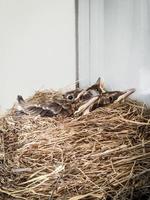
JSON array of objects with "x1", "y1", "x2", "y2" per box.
[{"x1": 79, "y1": 0, "x2": 150, "y2": 105}]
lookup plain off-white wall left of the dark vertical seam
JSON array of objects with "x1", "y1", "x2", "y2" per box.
[{"x1": 0, "y1": 0, "x2": 75, "y2": 109}]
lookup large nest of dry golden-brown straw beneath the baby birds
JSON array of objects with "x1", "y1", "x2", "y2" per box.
[{"x1": 0, "y1": 92, "x2": 150, "y2": 200}]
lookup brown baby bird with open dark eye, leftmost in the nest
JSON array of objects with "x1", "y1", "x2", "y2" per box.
[{"x1": 17, "y1": 78, "x2": 103, "y2": 117}]
